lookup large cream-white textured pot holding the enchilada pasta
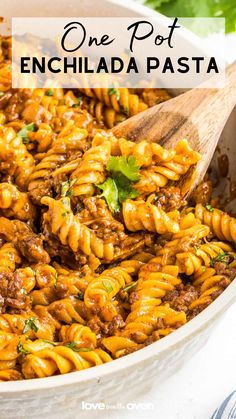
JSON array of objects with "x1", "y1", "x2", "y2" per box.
[{"x1": 0, "y1": 0, "x2": 236, "y2": 419}]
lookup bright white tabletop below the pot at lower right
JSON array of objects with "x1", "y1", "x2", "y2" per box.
[{"x1": 85, "y1": 304, "x2": 236, "y2": 419}]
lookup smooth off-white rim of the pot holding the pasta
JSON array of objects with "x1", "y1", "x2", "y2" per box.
[{"x1": 0, "y1": 0, "x2": 236, "y2": 399}]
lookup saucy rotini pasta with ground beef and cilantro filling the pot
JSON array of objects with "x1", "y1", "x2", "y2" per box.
[{"x1": 0, "y1": 37, "x2": 236, "y2": 381}]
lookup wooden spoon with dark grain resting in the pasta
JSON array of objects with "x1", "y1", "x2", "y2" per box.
[{"x1": 112, "y1": 61, "x2": 236, "y2": 196}]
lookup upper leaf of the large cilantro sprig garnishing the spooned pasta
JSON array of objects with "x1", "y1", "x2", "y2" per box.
[{"x1": 107, "y1": 156, "x2": 140, "y2": 182}]
